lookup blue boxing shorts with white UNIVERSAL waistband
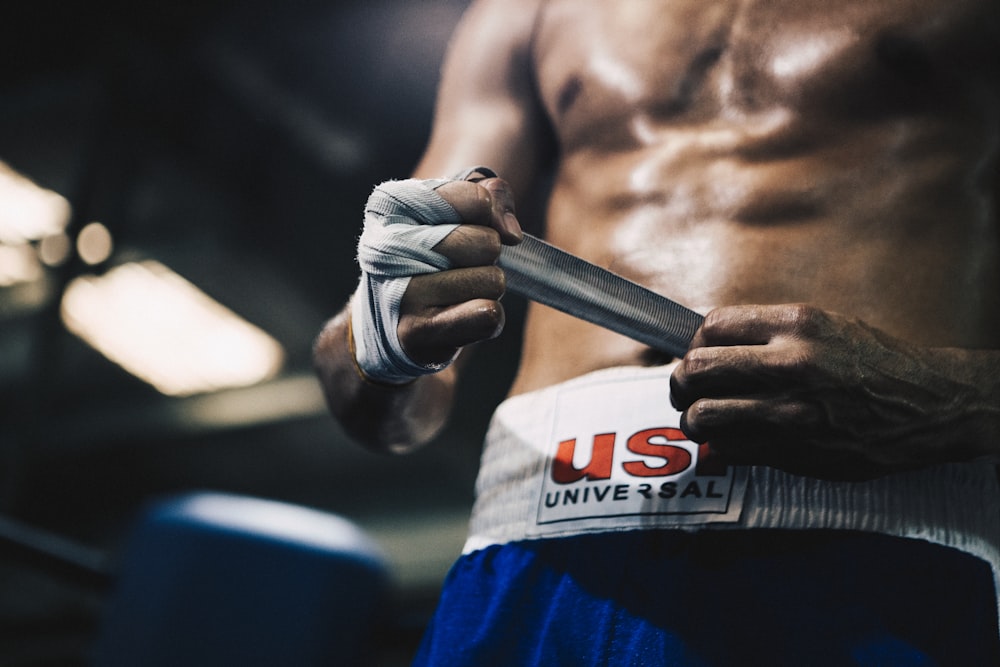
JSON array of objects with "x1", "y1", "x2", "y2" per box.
[{"x1": 417, "y1": 367, "x2": 1000, "y2": 665}]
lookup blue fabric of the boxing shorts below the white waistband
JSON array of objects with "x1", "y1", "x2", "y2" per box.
[{"x1": 415, "y1": 530, "x2": 1000, "y2": 667}]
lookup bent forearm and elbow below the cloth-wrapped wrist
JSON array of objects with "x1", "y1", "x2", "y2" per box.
[{"x1": 313, "y1": 307, "x2": 454, "y2": 453}]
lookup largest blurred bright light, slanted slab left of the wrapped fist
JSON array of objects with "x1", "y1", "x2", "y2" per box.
[{"x1": 62, "y1": 260, "x2": 284, "y2": 396}]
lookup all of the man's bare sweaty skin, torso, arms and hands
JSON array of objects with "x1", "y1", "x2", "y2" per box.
[{"x1": 316, "y1": 0, "x2": 1000, "y2": 479}]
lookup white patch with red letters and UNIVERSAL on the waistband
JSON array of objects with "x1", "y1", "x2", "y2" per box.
[{"x1": 532, "y1": 371, "x2": 746, "y2": 535}]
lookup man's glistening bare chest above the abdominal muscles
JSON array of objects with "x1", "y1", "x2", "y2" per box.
[{"x1": 535, "y1": 0, "x2": 1000, "y2": 144}]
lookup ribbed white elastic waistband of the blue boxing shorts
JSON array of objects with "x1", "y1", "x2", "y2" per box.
[{"x1": 466, "y1": 367, "x2": 1000, "y2": 620}]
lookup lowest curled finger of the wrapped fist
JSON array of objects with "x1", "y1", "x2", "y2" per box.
[{"x1": 399, "y1": 299, "x2": 506, "y2": 364}]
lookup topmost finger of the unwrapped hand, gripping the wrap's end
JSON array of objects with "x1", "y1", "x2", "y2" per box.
[{"x1": 691, "y1": 304, "x2": 829, "y2": 347}]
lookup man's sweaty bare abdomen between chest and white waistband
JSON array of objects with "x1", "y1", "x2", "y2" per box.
[{"x1": 511, "y1": 117, "x2": 1000, "y2": 394}]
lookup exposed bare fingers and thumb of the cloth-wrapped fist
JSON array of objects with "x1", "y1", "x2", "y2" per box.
[{"x1": 397, "y1": 178, "x2": 522, "y2": 364}]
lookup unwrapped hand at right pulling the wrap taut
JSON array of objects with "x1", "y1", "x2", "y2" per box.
[{"x1": 671, "y1": 305, "x2": 974, "y2": 479}]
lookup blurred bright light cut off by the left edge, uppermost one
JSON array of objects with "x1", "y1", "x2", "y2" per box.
[{"x1": 0, "y1": 161, "x2": 70, "y2": 245}]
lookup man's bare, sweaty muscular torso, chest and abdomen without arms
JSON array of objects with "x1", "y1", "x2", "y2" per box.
[{"x1": 513, "y1": 0, "x2": 1000, "y2": 393}]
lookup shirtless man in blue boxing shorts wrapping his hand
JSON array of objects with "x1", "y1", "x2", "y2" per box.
[{"x1": 316, "y1": 0, "x2": 1000, "y2": 664}]
